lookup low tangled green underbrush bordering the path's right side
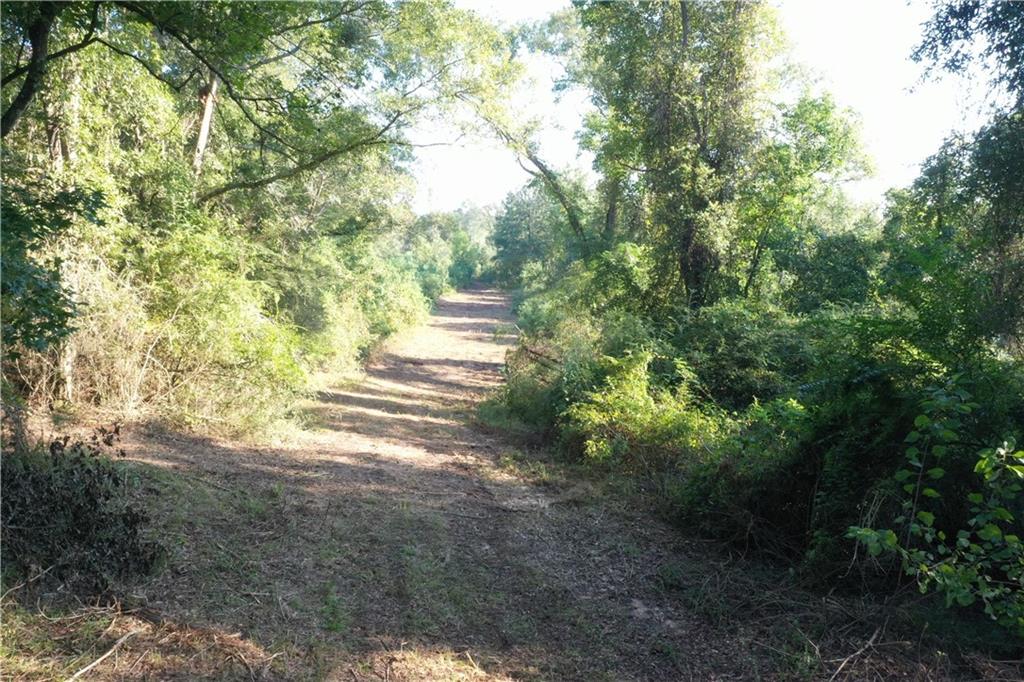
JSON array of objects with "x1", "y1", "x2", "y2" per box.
[{"x1": 501, "y1": 252, "x2": 1024, "y2": 632}]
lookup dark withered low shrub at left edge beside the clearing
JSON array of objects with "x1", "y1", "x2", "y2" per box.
[{"x1": 0, "y1": 433, "x2": 162, "y2": 592}]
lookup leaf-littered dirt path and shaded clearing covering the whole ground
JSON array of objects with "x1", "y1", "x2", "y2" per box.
[{"x1": 2, "y1": 289, "x2": 1013, "y2": 682}]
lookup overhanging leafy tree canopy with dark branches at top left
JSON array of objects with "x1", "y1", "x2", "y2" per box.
[{"x1": 3, "y1": 0, "x2": 520, "y2": 203}]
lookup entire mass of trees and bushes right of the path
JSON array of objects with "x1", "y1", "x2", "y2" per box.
[{"x1": 494, "y1": 2, "x2": 1024, "y2": 634}]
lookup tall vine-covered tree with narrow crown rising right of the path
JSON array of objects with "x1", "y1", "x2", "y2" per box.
[{"x1": 571, "y1": 2, "x2": 773, "y2": 306}]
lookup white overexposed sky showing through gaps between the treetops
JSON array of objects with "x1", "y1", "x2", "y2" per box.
[{"x1": 414, "y1": 0, "x2": 986, "y2": 213}]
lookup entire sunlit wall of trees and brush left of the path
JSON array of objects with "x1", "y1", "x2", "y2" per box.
[{"x1": 2, "y1": 1, "x2": 495, "y2": 432}]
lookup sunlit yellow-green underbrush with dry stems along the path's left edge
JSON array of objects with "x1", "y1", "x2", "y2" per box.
[{"x1": 4, "y1": 199, "x2": 479, "y2": 435}]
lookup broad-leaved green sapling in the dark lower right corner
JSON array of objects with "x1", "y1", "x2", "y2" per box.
[{"x1": 848, "y1": 382, "x2": 1024, "y2": 636}]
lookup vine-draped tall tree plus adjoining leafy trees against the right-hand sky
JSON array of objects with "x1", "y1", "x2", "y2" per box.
[{"x1": 516, "y1": 2, "x2": 862, "y2": 307}]
